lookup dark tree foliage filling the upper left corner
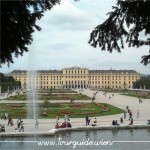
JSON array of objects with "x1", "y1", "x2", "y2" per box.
[{"x1": 0, "y1": 0, "x2": 60, "y2": 65}]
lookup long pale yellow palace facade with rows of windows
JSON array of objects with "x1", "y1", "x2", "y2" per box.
[{"x1": 11, "y1": 67, "x2": 140, "y2": 89}]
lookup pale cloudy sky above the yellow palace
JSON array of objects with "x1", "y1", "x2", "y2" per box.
[{"x1": 1, "y1": 0, "x2": 150, "y2": 74}]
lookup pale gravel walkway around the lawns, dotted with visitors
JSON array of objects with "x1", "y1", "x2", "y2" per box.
[{"x1": 0, "y1": 89, "x2": 150, "y2": 132}]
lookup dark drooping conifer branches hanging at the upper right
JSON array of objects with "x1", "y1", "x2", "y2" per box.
[{"x1": 89, "y1": 0, "x2": 150, "y2": 65}]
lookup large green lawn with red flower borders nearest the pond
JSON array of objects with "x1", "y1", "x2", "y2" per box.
[{"x1": 0, "y1": 101, "x2": 123, "y2": 119}]
